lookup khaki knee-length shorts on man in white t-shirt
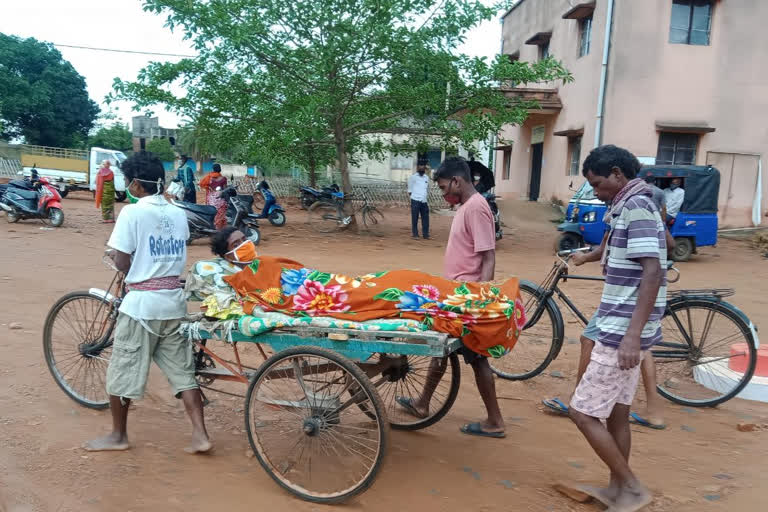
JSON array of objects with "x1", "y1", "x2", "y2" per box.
[{"x1": 107, "y1": 313, "x2": 198, "y2": 399}]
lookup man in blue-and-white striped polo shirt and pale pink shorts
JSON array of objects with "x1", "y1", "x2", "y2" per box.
[{"x1": 570, "y1": 145, "x2": 667, "y2": 512}]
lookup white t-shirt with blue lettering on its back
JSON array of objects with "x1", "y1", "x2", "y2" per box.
[{"x1": 107, "y1": 196, "x2": 189, "y2": 320}]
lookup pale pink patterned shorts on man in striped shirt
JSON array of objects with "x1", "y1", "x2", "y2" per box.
[{"x1": 571, "y1": 343, "x2": 644, "y2": 419}]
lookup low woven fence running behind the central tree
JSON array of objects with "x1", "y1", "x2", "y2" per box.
[{"x1": 234, "y1": 176, "x2": 448, "y2": 210}]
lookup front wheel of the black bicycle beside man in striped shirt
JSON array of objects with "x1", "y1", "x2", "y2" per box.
[{"x1": 488, "y1": 279, "x2": 564, "y2": 380}]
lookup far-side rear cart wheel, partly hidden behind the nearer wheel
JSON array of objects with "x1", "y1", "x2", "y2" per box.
[{"x1": 350, "y1": 352, "x2": 461, "y2": 430}]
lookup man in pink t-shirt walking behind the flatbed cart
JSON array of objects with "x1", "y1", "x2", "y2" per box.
[{"x1": 396, "y1": 157, "x2": 506, "y2": 438}]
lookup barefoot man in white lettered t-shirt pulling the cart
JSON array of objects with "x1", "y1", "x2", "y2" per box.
[{"x1": 83, "y1": 151, "x2": 212, "y2": 453}]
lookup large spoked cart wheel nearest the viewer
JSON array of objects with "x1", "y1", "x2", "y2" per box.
[{"x1": 245, "y1": 347, "x2": 389, "y2": 503}]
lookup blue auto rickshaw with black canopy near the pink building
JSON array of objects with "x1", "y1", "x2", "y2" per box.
[{"x1": 557, "y1": 165, "x2": 720, "y2": 261}]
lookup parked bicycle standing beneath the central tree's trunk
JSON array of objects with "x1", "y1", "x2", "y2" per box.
[{"x1": 308, "y1": 190, "x2": 384, "y2": 233}]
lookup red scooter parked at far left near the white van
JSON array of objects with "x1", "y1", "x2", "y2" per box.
[{"x1": 0, "y1": 169, "x2": 64, "y2": 228}]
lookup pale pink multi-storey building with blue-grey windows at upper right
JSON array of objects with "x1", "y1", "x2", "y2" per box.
[{"x1": 494, "y1": 0, "x2": 768, "y2": 227}]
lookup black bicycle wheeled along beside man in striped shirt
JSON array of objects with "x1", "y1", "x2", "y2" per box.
[{"x1": 490, "y1": 248, "x2": 760, "y2": 407}]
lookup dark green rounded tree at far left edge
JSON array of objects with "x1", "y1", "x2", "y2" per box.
[{"x1": 0, "y1": 34, "x2": 99, "y2": 147}]
